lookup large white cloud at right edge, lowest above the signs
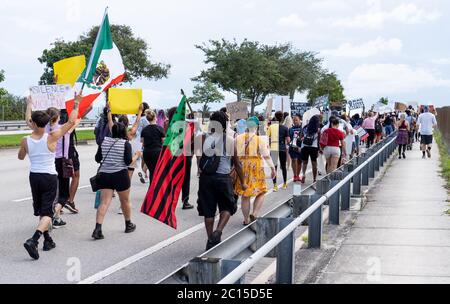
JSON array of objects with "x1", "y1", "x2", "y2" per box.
[{"x1": 345, "y1": 64, "x2": 450, "y2": 97}]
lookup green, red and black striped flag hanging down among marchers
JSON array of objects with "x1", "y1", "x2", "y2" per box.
[{"x1": 141, "y1": 96, "x2": 193, "y2": 229}]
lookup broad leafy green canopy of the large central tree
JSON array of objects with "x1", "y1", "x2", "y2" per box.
[{"x1": 194, "y1": 39, "x2": 322, "y2": 115}]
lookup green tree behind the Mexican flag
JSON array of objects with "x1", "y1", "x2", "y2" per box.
[{"x1": 38, "y1": 25, "x2": 170, "y2": 84}]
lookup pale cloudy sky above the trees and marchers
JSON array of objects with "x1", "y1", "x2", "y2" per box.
[{"x1": 0, "y1": 0, "x2": 450, "y2": 112}]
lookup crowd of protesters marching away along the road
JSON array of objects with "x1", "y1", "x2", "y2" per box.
[{"x1": 19, "y1": 96, "x2": 436, "y2": 259}]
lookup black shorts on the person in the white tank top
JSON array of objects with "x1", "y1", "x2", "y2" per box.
[{"x1": 30, "y1": 173, "x2": 58, "y2": 217}]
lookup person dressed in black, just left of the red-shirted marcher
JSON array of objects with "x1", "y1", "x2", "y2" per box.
[{"x1": 301, "y1": 115, "x2": 320, "y2": 184}]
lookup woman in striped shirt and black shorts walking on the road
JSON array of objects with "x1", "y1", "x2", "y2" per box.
[{"x1": 92, "y1": 122, "x2": 142, "y2": 240}]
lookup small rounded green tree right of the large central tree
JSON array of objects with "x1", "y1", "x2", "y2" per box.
[{"x1": 308, "y1": 73, "x2": 345, "y2": 105}]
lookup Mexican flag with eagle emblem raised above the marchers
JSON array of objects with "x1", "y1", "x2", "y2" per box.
[{"x1": 66, "y1": 12, "x2": 125, "y2": 117}]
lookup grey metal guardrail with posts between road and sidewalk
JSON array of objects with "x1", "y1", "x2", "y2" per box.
[{"x1": 158, "y1": 133, "x2": 396, "y2": 284}]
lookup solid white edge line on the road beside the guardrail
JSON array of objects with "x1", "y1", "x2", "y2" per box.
[{"x1": 78, "y1": 179, "x2": 298, "y2": 284}]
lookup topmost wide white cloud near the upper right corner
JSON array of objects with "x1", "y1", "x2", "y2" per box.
[{"x1": 332, "y1": 1, "x2": 441, "y2": 29}]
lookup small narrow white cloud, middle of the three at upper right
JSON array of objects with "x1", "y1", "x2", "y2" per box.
[{"x1": 321, "y1": 37, "x2": 403, "y2": 58}]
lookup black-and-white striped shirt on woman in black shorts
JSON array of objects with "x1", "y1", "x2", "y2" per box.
[{"x1": 95, "y1": 137, "x2": 132, "y2": 173}]
